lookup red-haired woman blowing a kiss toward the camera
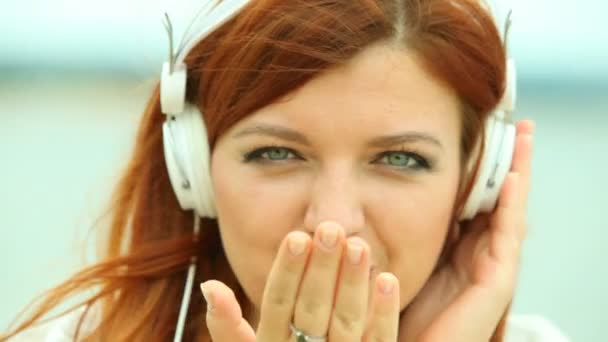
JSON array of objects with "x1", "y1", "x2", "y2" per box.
[{"x1": 2, "y1": 0, "x2": 568, "y2": 342}]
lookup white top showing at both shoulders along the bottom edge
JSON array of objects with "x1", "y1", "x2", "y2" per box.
[{"x1": 10, "y1": 309, "x2": 571, "y2": 342}]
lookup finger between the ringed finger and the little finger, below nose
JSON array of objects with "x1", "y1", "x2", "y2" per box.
[{"x1": 328, "y1": 237, "x2": 370, "y2": 341}]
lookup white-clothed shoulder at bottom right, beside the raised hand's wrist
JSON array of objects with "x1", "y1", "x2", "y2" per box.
[{"x1": 505, "y1": 314, "x2": 570, "y2": 342}]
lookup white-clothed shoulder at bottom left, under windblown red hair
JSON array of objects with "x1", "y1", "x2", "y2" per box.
[{"x1": 9, "y1": 307, "x2": 96, "y2": 342}]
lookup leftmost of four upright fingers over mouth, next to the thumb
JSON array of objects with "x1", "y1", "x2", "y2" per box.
[{"x1": 258, "y1": 232, "x2": 311, "y2": 341}]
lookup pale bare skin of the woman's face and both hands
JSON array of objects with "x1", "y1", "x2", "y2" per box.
[{"x1": 202, "y1": 45, "x2": 533, "y2": 342}]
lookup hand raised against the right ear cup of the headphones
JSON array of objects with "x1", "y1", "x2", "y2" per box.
[{"x1": 399, "y1": 120, "x2": 534, "y2": 342}]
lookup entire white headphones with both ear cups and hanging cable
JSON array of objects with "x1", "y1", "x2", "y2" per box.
[{"x1": 160, "y1": 0, "x2": 516, "y2": 342}]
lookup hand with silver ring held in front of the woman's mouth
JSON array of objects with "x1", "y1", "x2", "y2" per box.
[{"x1": 201, "y1": 222, "x2": 399, "y2": 342}]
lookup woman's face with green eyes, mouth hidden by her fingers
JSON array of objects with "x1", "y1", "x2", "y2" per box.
[{"x1": 212, "y1": 42, "x2": 461, "y2": 309}]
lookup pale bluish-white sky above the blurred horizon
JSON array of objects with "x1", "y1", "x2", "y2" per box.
[{"x1": 0, "y1": 0, "x2": 608, "y2": 81}]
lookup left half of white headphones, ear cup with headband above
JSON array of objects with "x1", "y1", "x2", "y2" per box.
[{"x1": 160, "y1": 0, "x2": 250, "y2": 218}]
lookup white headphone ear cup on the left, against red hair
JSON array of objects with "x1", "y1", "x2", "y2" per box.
[{"x1": 163, "y1": 103, "x2": 217, "y2": 218}]
